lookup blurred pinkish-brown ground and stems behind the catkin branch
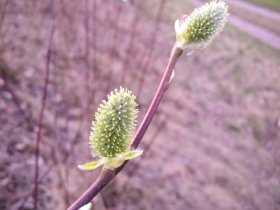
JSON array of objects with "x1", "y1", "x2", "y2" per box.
[{"x1": 0, "y1": 0, "x2": 280, "y2": 210}]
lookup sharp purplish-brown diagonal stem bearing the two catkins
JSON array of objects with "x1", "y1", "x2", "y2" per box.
[{"x1": 67, "y1": 45, "x2": 183, "y2": 210}]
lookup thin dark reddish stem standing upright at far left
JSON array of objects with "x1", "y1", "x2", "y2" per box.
[{"x1": 33, "y1": 25, "x2": 55, "y2": 210}]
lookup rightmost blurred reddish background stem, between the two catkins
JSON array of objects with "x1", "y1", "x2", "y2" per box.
[{"x1": 136, "y1": 0, "x2": 165, "y2": 98}]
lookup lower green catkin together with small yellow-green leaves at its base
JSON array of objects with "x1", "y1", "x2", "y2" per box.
[{"x1": 78, "y1": 87, "x2": 143, "y2": 171}]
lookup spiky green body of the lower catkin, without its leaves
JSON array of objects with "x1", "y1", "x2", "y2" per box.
[{"x1": 89, "y1": 88, "x2": 138, "y2": 158}]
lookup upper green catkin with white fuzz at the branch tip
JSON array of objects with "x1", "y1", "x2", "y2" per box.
[{"x1": 175, "y1": 0, "x2": 228, "y2": 49}]
